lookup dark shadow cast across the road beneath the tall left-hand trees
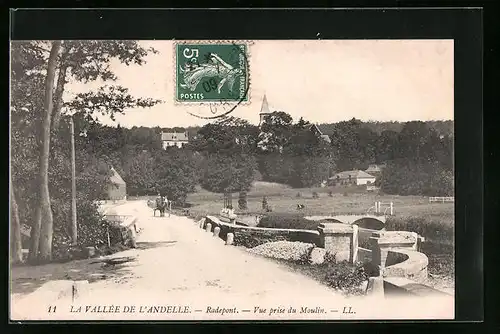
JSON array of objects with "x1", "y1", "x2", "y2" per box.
[{"x1": 10, "y1": 254, "x2": 136, "y2": 294}]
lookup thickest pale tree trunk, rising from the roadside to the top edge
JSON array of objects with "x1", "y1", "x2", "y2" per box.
[{"x1": 30, "y1": 41, "x2": 61, "y2": 262}]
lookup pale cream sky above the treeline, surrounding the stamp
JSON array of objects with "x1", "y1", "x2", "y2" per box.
[{"x1": 65, "y1": 40, "x2": 454, "y2": 127}]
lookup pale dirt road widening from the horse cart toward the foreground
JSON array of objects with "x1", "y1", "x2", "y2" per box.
[{"x1": 11, "y1": 201, "x2": 454, "y2": 320}]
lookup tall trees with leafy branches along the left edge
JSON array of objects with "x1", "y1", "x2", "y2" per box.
[{"x1": 11, "y1": 41, "x2": 160, "y2": 261}]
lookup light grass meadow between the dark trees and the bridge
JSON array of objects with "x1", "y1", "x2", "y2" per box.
[{"x1": 183, "y1": 182, "x2": 454, "y2": 225}]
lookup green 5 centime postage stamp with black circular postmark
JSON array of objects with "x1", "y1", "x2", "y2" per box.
[{"x1": 175, "y1": 41, "x2": 249, "y2": 103}]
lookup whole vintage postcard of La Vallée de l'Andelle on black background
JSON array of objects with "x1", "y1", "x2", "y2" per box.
[{"x1": 10, "y1": 39, "x2": 455, "y2": 321}]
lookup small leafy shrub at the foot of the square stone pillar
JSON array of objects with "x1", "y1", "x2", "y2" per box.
[{"x1": 325, "y1": 261, "x2": 368, "y2": 295}]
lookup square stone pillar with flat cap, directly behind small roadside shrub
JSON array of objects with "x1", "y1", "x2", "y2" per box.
[{"x1": 318, "y1": 223, "x2": 353, "y2": 262}]
